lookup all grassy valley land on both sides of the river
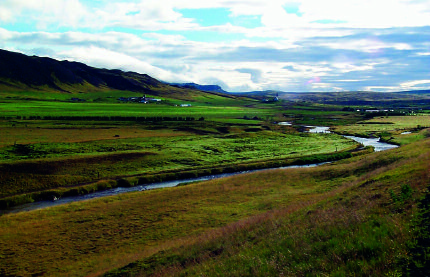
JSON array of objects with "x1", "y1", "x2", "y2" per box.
[{"x1": 0, "y1": 91, "x2": 430, "y2": 276}]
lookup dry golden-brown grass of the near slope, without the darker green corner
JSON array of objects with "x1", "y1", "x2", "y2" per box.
[{"x1": 0, "y1": 137, "x2": 430, "y2": 276}]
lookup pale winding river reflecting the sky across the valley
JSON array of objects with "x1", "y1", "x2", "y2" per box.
[{"x1": 0, "y1": 126, "x2": 398, "y2": 215}]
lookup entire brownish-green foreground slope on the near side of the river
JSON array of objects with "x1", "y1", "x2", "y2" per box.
[{"x1": 0, "y1": 135, "x2": 430, "y2": 276}]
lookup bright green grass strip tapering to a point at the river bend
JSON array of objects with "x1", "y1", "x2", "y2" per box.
[{"x1": 0, "y1": 131, "x2": 356, "y2": 164}]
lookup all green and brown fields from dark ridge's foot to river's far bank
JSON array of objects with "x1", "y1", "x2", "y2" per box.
[{"x1": 0, "y1": 92, "x2": 358, "y2": 207}]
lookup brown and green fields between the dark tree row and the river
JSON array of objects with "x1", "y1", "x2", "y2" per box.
[{"x1": 0, "y1": 117, "x2": 357, "y2": 206}]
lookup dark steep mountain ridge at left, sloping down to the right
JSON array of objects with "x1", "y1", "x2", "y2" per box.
[{"x1": 0, "y1": 49, "x2": 235, "y2": 99}]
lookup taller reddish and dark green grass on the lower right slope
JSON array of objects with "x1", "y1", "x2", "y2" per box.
[{"x1": 106, "y1": 138, "x2": 430, "y2": 276}]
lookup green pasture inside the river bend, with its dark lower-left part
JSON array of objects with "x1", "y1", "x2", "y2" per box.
[{"x1": 0, "y1": 131, "x2": 357, "y2": 197}]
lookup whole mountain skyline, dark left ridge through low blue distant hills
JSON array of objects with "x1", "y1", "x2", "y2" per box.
[{"x1": 0, "y1": 49, "x2": 430, "y2": 105}]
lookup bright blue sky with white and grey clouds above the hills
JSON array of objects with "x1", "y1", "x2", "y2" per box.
[{"x1": 0, "y1": 0, "x2": 430, "y2": 92}]
